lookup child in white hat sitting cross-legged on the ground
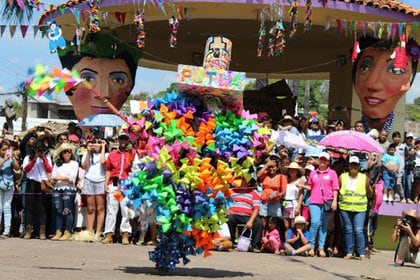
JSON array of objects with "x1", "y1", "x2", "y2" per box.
[{"x1": 284, "y1": 216, "x2": 311, "y2": 256}]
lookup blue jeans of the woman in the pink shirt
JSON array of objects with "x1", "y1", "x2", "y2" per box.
[{"x1": 309, "y1": 204, "x2": 331, "y2": 250}]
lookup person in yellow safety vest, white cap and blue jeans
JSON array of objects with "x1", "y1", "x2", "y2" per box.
[{"x1": 338, "y1": 156, "x2": 371, "y2": 260}]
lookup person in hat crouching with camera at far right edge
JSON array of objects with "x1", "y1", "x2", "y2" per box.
[{"x1": 392, "y1": 209, "x2": 420, "y2": 267}]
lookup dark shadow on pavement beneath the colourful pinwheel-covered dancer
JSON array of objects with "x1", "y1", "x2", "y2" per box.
[{"x1": 120, "y1": 266, "x2": 256, "y2": 278}]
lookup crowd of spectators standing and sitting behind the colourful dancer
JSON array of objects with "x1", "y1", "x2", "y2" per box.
[{"x1": 0, "y1": 113, "x2": 420, "y2": 266}]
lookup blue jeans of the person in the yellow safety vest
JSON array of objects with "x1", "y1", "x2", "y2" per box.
[{"x1": 340, "y1": 210, "x2": 366, "y2": 255}]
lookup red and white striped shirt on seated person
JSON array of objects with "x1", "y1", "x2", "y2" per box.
[{"x1": 229, "y1": 190, "x2": 261, "y2": 216}]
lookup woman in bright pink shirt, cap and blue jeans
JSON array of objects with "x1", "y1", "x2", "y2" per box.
[{"x1": 307, "y1": 152, "x2": 340, "y2": 257}]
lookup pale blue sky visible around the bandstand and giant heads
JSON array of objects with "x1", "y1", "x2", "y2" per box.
[{"x1": 0, "y1": 0, "x2": 420, "y2": 105}]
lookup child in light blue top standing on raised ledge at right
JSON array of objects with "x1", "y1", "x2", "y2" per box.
[{"x1": 381, "y1": 143, "x2": 400, "y2": 202}]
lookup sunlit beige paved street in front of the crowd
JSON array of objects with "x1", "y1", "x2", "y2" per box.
[{"x1": 0, "y1": 238, "x2": 420, "y2": 280}]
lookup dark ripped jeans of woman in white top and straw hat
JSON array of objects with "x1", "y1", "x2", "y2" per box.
[{"x1": 53, "y1": 189, "x2": 76, "y2": 232}]
